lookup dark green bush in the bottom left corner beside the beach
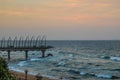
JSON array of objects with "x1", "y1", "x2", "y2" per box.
[{"x1": 0, "y1": 57, "x2": 15, "y2": 80}]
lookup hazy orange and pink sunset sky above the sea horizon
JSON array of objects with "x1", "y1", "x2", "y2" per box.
[{"x1": 0, "y1": 0, "x2": 120, "y2": 40}]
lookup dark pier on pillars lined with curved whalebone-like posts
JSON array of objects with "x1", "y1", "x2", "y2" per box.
[{"x1": 0, "y1": 36, "x2": 53, "y2": 61}]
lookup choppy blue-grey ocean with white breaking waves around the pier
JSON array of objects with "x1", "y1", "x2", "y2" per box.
[{"x1": 0, "y1": 40, "x2": 120, "y2": 80}]
